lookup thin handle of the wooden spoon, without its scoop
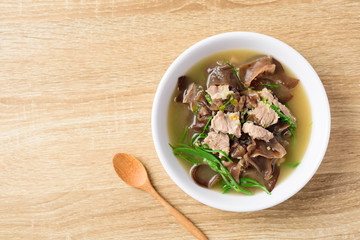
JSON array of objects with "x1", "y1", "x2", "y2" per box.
[{"x1": 144, "y1": 184, "x2": 208, "y2": 240}]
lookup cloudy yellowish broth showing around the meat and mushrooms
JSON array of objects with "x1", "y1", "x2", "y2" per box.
[{"x1": 167, "y1": 49, "x2": 312, "y2": 194}]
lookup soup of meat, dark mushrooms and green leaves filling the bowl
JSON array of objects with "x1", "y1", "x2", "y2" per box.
[{"x1": 168, "y1": 50, "x2": 311, "y2": 194}]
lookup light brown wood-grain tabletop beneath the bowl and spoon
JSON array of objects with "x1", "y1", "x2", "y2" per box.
[{"x1": 0, "y1": 0, "x2": 360, "y2": 239}]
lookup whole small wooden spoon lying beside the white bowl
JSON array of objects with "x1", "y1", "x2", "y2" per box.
[{"x1": 113, "y1": 153, "x2": 207, "y2": 239}]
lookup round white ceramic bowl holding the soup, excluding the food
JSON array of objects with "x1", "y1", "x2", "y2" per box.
[{"x1": 151, "y1": 32, "x2": 330, "y2": 212}]
